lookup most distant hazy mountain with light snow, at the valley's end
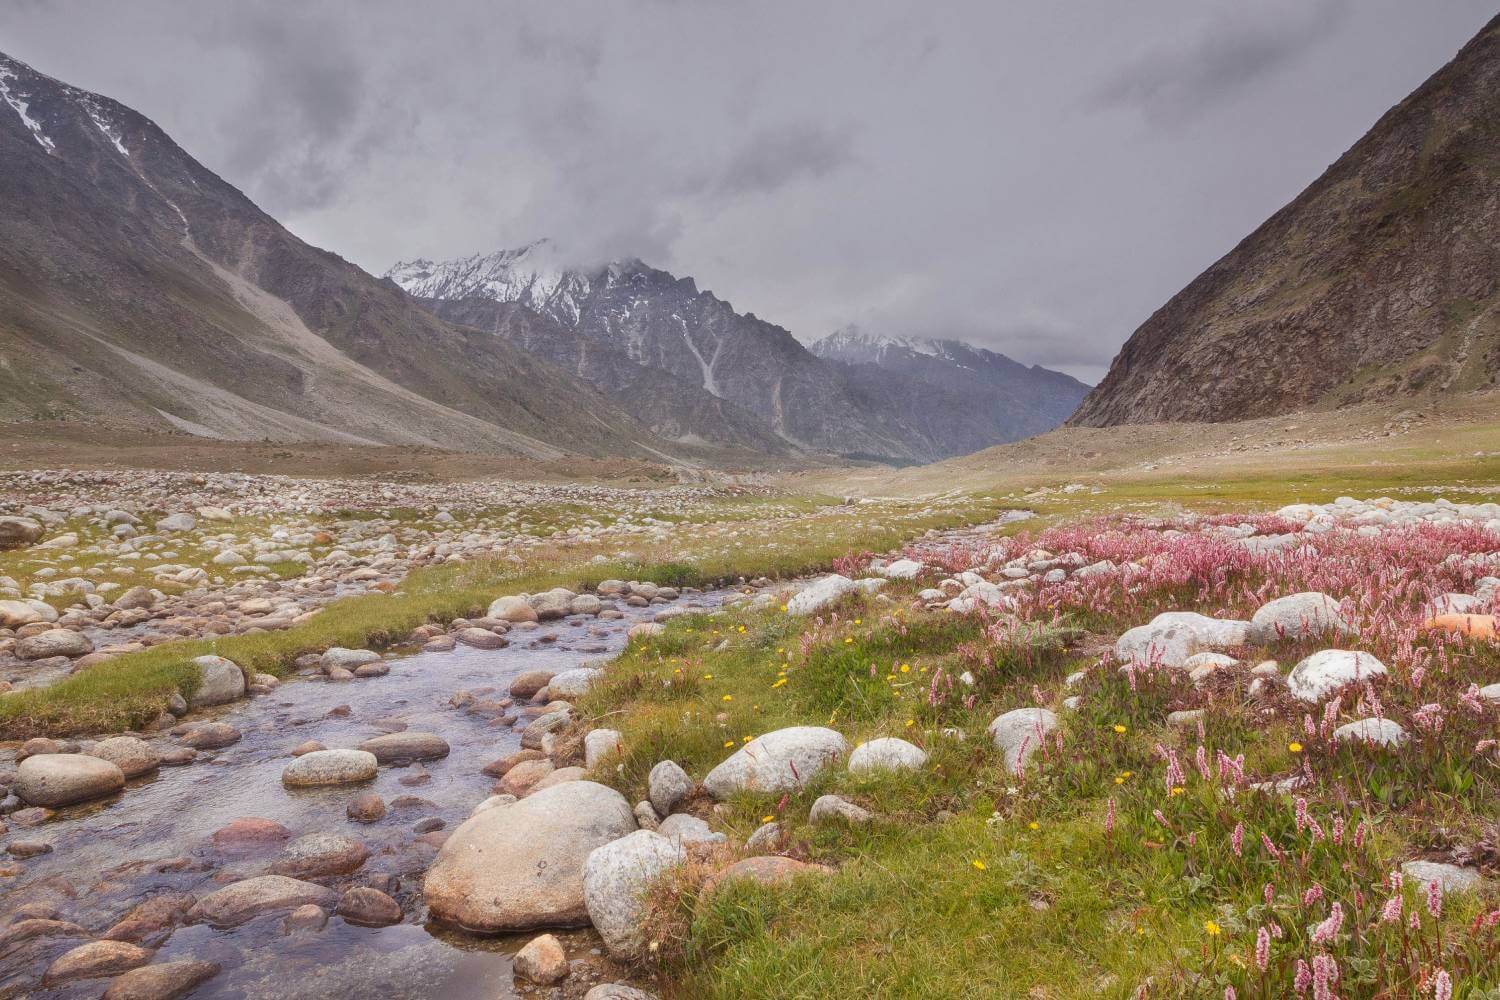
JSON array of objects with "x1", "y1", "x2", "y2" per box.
[{"x1": 812, "y1": 327, "x2": 1089, "y2": 454}]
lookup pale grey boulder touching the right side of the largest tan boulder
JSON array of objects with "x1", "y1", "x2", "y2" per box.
[{"x1": 584, "y1": 831, "x2": 687, "y2": 963}]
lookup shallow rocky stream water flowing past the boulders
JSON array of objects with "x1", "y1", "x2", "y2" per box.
[{"x1": 0, "y1": 592, "x2": 723, "y2": 1000}]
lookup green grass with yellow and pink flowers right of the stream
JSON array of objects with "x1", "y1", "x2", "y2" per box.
[{"x1": 564, "y1": 481, "x2": 1500, "y2": 1000}]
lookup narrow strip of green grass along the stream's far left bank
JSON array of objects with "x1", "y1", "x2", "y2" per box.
[{"x1": 0, "y1": 498, "x2": 998, "y2": 739}]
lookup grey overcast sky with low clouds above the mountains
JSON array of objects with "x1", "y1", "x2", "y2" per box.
[{"x1": 0, "y1": 0, "x2": 1494, "y2": 381}]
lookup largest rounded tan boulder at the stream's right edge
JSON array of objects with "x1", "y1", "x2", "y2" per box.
[{"x1": 423, "y1": 781, "x2": 636, "y2": 933}]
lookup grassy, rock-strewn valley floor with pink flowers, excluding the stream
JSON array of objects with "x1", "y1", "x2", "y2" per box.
[{"x1": 0, "y1": 414, "x2": 1500, "y2": 1000}]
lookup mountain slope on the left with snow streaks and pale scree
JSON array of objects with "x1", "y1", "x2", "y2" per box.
[{"x1": 0, "y1": 48, "x2": 699, "y2": 460}]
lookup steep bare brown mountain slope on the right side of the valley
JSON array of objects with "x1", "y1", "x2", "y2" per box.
[{"x1": 1071, "y1": 18, "x2": 1500, "y2": 426}]
